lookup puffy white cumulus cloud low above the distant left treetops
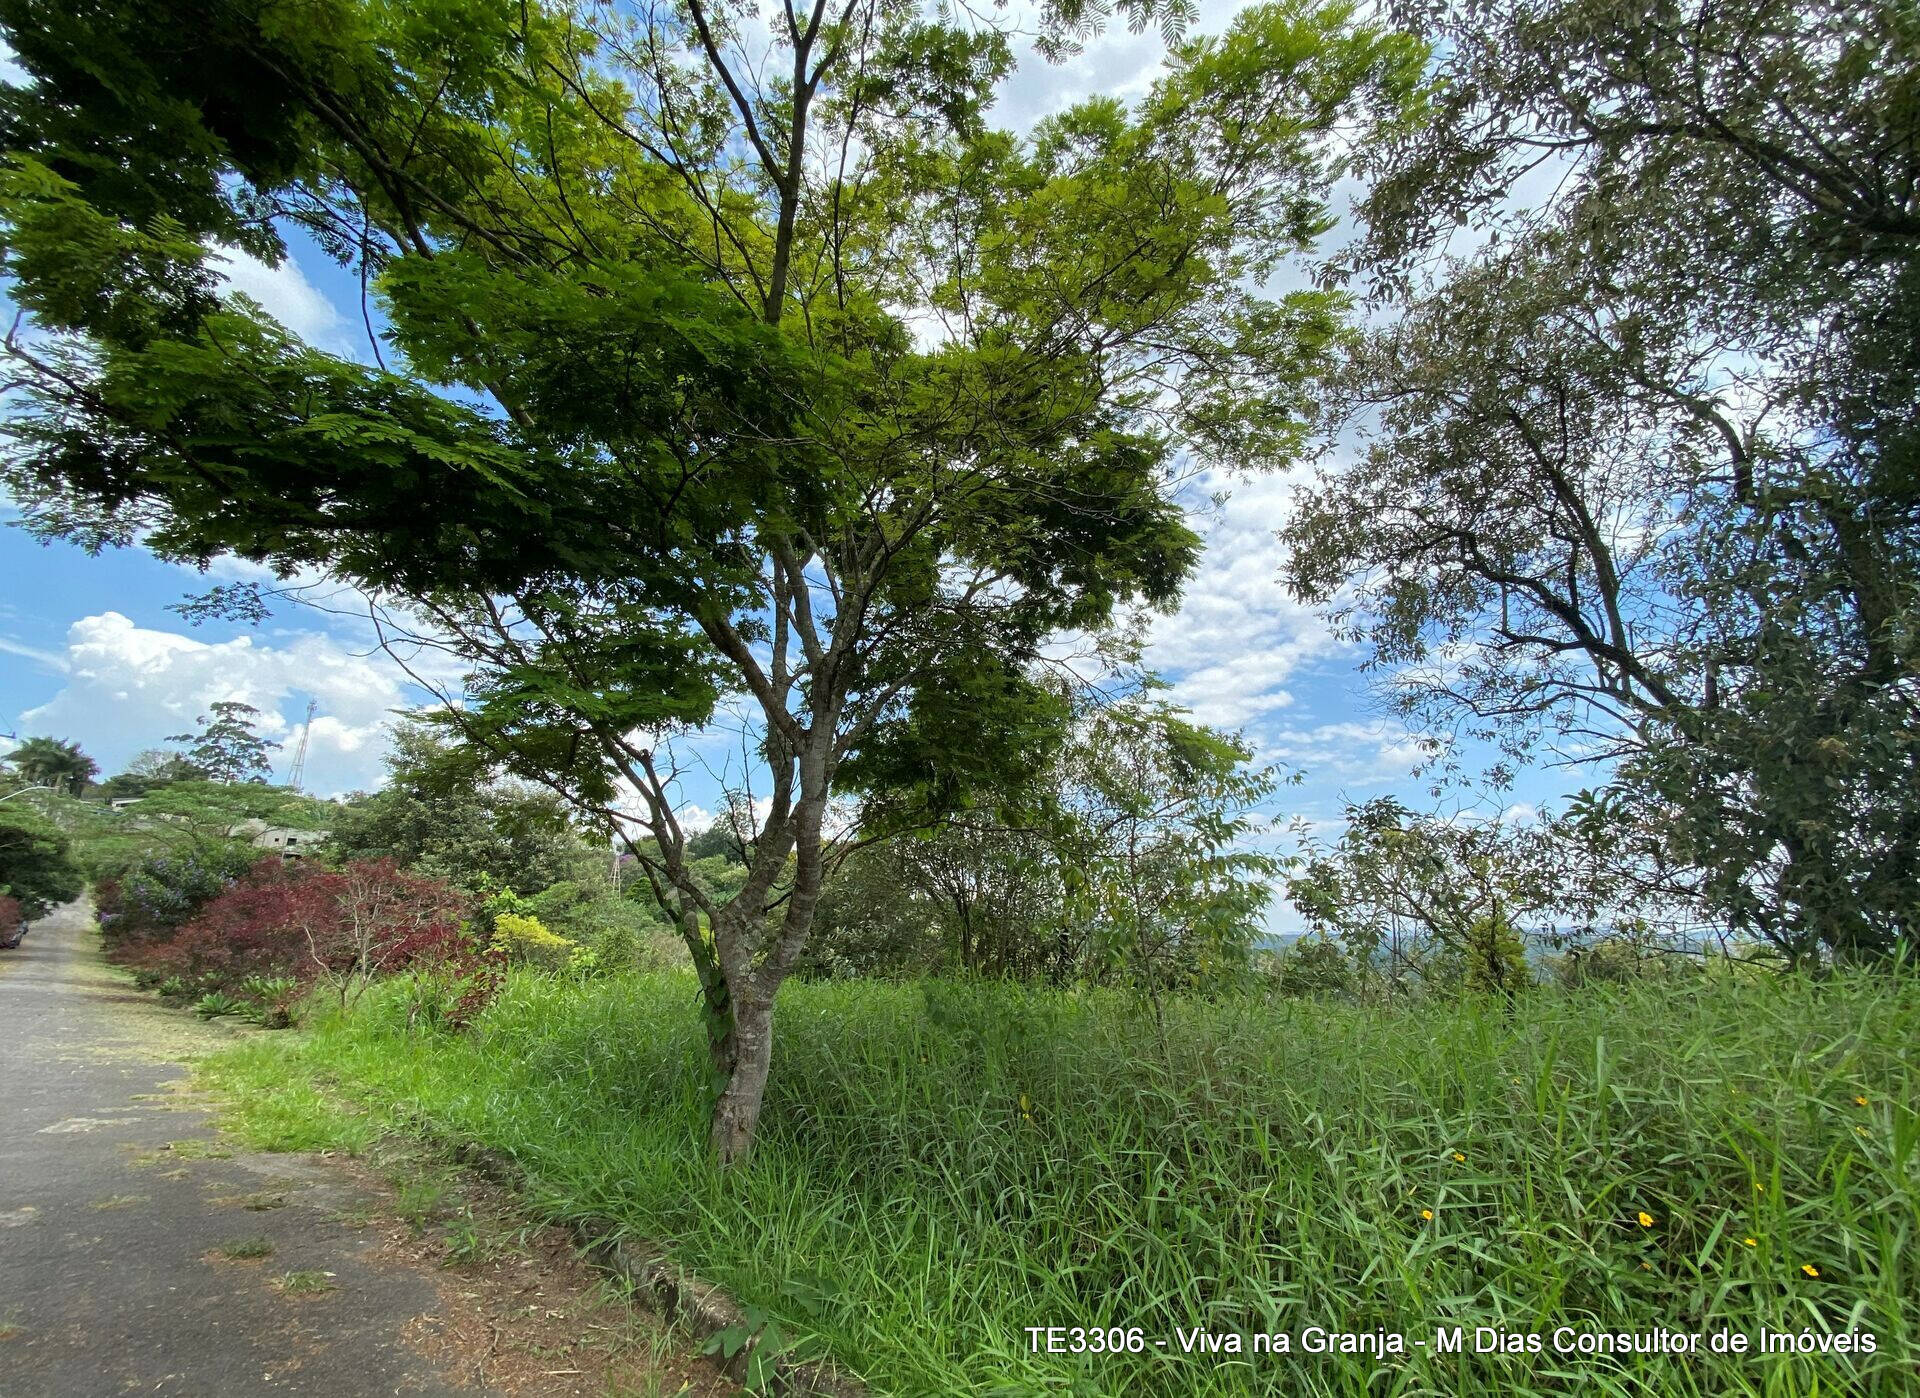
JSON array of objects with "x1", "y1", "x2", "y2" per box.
[{"x1": 19, "y1": 611, "x2": 415, "y2": 795}]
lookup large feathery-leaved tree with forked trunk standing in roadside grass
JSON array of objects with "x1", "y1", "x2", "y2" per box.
[{"x1": 0, "y1": 0, "x2": 1419, "y2": 1162}]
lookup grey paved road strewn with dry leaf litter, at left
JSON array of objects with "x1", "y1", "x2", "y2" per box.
[{"x1": 0, "y1": 904, "x2": 488, "y2": 1398}]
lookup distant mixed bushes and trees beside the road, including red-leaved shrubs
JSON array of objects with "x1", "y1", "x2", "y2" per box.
[{"x1": 0, "y1": 733, "x2": 687, "y2": 1027}]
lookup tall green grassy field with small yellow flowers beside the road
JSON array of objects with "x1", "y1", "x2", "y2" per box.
[{"x1": 211, "y1": 974, "x2": 1920, "y2": 1394}]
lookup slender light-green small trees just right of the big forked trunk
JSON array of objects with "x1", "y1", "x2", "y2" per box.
[{"x1": 810, "y1": 682, "x2": 1279, "y2": 1004}]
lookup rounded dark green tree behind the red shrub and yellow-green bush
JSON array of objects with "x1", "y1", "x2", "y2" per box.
[{"x1": 326, "y1": 720, "x2": 583, "y2": 893}]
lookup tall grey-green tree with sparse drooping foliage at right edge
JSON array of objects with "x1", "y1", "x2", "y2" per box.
[{"x1": 1284, "y1": 0, "x2": 1920, "y2": 958}]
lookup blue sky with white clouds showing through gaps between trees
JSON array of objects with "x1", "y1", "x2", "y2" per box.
[{"x1": 0, "y1": 4, "x2": 1590, "y2": 926}]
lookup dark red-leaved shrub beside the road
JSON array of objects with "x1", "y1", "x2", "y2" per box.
[{"x1": 136, "y1": 860, "x2": 482, "y2": 1002}]
